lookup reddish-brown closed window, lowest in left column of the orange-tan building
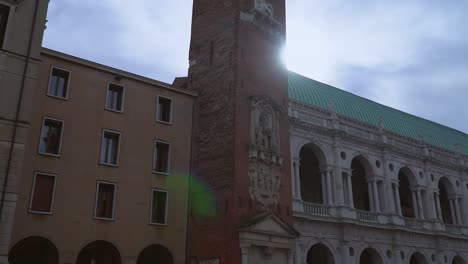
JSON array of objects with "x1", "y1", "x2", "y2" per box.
[{"x1": 31, "y1": 174, "x2": 55, "y2": 213}]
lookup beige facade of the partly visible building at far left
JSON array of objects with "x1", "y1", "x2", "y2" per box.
[{"x1": 0, "y1": 0, "x2": 48, "y2": 264}]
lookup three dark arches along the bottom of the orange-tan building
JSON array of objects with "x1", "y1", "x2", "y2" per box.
[{"x1": 8, "y1": 236, "x2": 174, "y2": 264}]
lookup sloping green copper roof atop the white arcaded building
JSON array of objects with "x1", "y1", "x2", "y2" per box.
[{"x1": 289, "y1": 72, "x2": 468, "y2": 155}]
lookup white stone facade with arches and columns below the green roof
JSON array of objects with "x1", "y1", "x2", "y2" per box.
[{"x1": 289, "y1": 101, "x2": 468, "y2": 264}]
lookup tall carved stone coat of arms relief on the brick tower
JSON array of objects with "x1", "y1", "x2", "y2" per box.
[{"x1": 249, "y1": 97, "x2": 283, "y2": 208}]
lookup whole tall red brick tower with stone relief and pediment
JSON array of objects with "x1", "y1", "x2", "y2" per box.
[{"x1": 188, "y1": 0, "x2": 296, "y2": 264}]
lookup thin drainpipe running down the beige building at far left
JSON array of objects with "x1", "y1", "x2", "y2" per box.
[{"x1": 0, "y1": 0, "x2": 39, "y2": 221}]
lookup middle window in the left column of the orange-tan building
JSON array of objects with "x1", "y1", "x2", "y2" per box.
[{"x1": 39, "y1": 118, "x2": 63, "y2": 155}]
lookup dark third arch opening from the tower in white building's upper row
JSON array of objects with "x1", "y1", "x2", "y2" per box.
[{"x1": 398, "y1": 167, "x2": 417, "y2": 218}]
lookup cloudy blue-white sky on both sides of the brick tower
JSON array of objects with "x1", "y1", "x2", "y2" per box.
[{"x1": 44, "y1": 0, "x2": 468, "y2": 132}]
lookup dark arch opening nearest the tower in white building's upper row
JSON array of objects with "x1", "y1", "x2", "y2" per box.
[{"x1": 299, "y1": 144, "x2": 326, "y2": 204}]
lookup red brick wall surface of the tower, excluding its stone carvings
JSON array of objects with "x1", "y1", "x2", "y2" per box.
[{"x1": 188, "y1": 0, "x2": 292, "y2": 263}]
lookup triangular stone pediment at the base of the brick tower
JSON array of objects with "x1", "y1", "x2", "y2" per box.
[{"x1": 239, "y1": 213, "x2": 298, "y2": 237}]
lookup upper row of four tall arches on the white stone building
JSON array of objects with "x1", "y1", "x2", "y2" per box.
[{"x1": 293, "y1": 143, "x2": 462, "y2": 225}]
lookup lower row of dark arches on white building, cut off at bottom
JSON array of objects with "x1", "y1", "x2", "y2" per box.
[{"x1": 305, "y1": 243, "x2": 466, "y2": 264}]
